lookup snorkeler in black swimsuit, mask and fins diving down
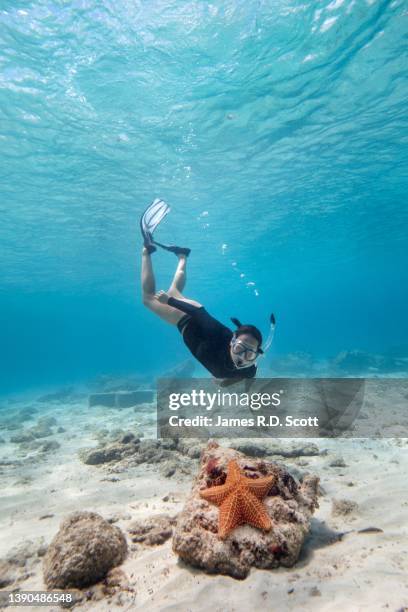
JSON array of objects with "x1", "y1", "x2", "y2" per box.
[{"x1": 140, "y1": 199, "x2": 275, "y2": 382}]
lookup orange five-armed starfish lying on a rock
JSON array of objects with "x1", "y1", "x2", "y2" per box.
[{"x1": 200, "y1": 460, "x2": 275, "y2": 540}]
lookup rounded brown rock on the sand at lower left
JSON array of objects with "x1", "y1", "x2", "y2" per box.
[{"x1": 43, "y1": 512, "x2": 127, "y2": 589}]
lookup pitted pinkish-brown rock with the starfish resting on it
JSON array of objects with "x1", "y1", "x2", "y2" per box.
[{"x1": 173, "y1": 442, "x2": 319, "y2": 578}]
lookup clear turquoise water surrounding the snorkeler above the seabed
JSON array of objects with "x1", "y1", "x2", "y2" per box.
[{"x1": 0, "y1": 0, "x2": 408, "y2": 391}]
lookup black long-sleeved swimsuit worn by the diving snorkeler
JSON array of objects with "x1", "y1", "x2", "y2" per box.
[{"x1": 168, "y1": 297, "x2": 256, "y2": 378}]
